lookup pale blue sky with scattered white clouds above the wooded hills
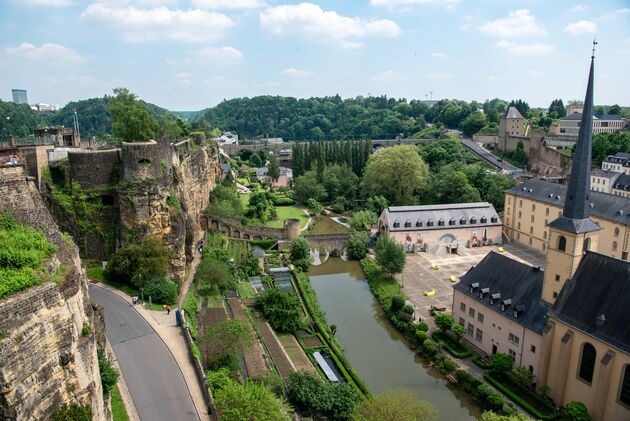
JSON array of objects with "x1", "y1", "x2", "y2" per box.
[{"x1": 0, "y1": 0, "x2": 630, "y2": 110}]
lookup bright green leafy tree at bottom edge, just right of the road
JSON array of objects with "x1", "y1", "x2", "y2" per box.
[{"x1": 213, "y1": 380, "x2": 291, "y2": 421}]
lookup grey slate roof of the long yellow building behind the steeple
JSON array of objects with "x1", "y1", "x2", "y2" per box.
[{"x1": 507, "y1": 178, "x2": 630, "y2": 225}]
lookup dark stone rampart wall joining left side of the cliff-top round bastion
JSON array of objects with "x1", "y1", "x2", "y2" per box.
[{"x1": 68, "y1": 149, "x2": 120, "y2": 190}]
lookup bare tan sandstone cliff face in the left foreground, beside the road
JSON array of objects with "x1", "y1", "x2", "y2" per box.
[{"x1": 0, "y1": 166, "x2": 108, "y2": 420}]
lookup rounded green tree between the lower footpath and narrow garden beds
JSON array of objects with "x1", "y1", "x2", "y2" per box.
[{"x1": 200, "y1": 320, "x2": 251, "y2": 365}]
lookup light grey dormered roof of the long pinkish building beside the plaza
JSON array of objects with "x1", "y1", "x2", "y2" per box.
[{"x1": 381, "y1": 202, "x2": 501, "y2": 231}]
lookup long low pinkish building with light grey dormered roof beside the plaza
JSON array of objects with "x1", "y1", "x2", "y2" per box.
[{"x1": 378, "y1": 202, "x2": 501, "y2": 253}]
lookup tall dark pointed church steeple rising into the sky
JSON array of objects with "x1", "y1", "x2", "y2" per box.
[{"x1": 550, "y1": 41, "x2": 600, "y2": 233}]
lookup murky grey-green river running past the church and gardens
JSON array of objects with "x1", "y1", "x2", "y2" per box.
[{"x1": 309, "y1": 257, "x2": 480, "y2": 421}]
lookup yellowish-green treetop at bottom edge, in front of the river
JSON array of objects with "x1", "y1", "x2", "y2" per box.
[{"x1": 352, "y1": 390, "x2": 438, "y2": 421}]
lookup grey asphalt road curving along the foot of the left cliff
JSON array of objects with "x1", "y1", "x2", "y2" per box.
[{"x1": 90, "y1": 285, "x2": 199, "y2": 421}]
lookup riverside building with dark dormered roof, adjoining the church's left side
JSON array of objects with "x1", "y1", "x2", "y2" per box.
[{"x1": 453, "y1": 251, "x2": 550, "y2": 376}]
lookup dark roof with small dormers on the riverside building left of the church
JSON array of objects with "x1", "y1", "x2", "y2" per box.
[{"x1": 453, "y1": 251, "x2": 550, "y2": 333}]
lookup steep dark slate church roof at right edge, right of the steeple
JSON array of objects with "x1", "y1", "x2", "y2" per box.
[{"x1": 550, "y1": 251, "x2": 630, "y2": 354}]
